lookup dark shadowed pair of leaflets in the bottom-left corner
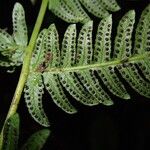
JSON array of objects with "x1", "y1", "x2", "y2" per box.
[{"x1": 2, "y1": 114, "x2": 50, "y2": 150}]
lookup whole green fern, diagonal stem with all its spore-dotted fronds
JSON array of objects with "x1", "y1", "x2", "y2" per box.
[{"x1": 0, "y1": 0, "x2": 150, "y2": 149}]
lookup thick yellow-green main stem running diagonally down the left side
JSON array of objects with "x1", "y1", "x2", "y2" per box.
[{"x1": 0, "y1": 0, "x2": 48, "y2": 150}]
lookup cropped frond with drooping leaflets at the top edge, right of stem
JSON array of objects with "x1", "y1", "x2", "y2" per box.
[{"x1": 49, "y1": 0, "x2": 120, "y2": 23}]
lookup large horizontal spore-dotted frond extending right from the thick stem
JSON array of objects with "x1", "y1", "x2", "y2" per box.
[{"x1": 25, "y1": 4, "x2": 150, "y2": 124}]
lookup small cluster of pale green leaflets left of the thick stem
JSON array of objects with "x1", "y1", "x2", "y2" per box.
[{"x1": 0, "y1": 3, "x2": 28, "y2": 67}]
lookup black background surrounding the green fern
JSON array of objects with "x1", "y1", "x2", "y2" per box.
[{"x1": 0, "y1": 0, "x2": 150, "y2": 150}]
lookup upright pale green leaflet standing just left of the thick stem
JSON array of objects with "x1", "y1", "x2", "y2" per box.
[{"x1": 12, "y1": 3, "x2": 28, "y2": 66}]
